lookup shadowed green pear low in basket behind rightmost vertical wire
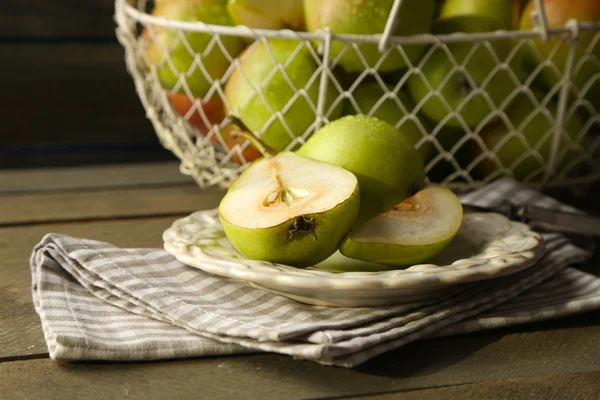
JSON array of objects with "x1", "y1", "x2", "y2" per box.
[{"x1": 473, "y1": 93, "x2": 584, "y2": 180}]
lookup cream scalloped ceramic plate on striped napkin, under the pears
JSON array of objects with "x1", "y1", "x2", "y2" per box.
[{"x1": 163, "y1": 210, "x2": 543, "y2": 307}]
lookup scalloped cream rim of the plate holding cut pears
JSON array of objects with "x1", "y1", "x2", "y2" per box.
[{"x1": 163, "y1": 209, "x2": 544, "y2": 290}]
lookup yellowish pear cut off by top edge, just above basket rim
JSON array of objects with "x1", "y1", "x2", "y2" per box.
[{"x1": 227, "y1": 0, "x2": 304, "y2": 30}]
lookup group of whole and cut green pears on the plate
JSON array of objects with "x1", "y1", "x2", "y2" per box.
[{"x1": 219, "y1": 115, "x2": 462, "y2": 269}]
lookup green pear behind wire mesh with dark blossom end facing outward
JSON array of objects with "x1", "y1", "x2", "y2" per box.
[{"x1": 407, "y1": 41, "x2": 521, "y2": 128}]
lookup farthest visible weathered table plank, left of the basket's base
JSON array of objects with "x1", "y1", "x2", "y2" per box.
[{"x1": 0, "y1": 161, "x2": 193, "y2": 194}]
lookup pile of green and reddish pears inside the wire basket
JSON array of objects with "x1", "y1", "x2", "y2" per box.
[{"x1": 142, "y1": 0, "x2": 600, "y2": 184}]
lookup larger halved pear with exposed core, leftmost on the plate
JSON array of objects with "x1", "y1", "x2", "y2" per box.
[{"x1": 219, "y1": 152, "x2": 360, "y2": 267}]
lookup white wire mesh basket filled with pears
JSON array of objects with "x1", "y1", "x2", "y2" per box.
[{"x1": 115, "y1": 0, "x2": 600, "y2": 190}]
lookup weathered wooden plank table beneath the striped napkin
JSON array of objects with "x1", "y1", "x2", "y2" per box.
[{"x1": 0, "y1": 163, "x2": 600, "y2": 400}]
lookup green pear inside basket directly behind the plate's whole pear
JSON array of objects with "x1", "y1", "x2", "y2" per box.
[{"x1": 342, "y1": 82, "x2": 432, "y2": 160}]
